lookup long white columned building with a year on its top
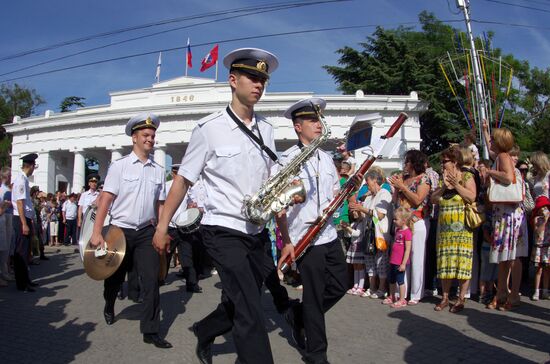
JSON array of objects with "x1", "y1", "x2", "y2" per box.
[{"x1": 5, "y1": 77, "x2": 427, "y2": 192}]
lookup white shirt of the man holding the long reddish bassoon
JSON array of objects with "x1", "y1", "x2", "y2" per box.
[{"x1": 281, "y1": 145, "x2": 340, "y2": 245}]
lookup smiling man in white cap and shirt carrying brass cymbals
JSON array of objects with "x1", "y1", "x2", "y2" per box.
[{"x1": 90, "y1": 113, "x2": 172, "y2": 349}]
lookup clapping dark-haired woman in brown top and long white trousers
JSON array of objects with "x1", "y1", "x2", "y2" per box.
[{"x1": 388, "y1": 150, "x2": 430, "y2": 306}]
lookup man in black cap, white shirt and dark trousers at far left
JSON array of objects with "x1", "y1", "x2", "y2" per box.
[{"x1": 11, "y1": 153, "x2": 38, "y2": 292}]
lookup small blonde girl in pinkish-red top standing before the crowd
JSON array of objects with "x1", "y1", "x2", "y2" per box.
[{"x1": 382, "y1": 207, "x2": 412, "y2": 308}]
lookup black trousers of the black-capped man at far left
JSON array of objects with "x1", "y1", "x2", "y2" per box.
[{"x1": 12, "y1": 215, "x2": 33, "y2": 290}]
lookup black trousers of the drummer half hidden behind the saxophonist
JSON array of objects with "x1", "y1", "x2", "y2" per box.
[{"x1": 166, "y1": 228, "x2": 202, "y2": 286}]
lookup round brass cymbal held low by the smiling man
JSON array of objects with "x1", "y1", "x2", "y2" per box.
[{"x1": 84, "y1": 225, "x2": 126, "y2": 281}]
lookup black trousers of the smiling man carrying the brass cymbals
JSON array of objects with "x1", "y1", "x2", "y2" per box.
[{"x1": 103, "y1": 225, "x2": 160, "y2": 334}]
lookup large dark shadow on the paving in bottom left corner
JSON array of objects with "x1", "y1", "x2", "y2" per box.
[{"x1": 0, "y1": 253, "x2": 96, "y2": 364}]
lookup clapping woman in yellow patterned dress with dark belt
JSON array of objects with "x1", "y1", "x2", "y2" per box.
[{"x1": 432, "y1": 147, "x2": 477, "y2": 313}]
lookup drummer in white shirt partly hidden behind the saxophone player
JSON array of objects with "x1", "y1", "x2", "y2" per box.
[{"x1": 166, "y1": 164, "x2": 204, "y2": 293}]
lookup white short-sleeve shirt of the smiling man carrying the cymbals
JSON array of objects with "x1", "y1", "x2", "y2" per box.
[{"x1": 103, "y1": 152, "x2": 166, "y2": 229}]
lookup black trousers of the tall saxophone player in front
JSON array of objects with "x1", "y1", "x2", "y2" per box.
[{"x1": 197, "y1": 225, "x2": 273, "y2": 364}]
